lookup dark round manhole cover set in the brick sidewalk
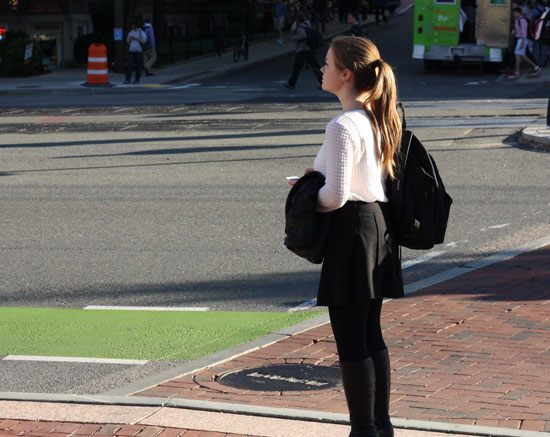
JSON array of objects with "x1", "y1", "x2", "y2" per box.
[{"x1": 216, "y1": 364, "x2": 340, "y2": 391}]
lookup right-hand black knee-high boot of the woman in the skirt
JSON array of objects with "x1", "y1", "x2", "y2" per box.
[{"x1": 370, "y1": 349, "x2": 394, "y2": 437}]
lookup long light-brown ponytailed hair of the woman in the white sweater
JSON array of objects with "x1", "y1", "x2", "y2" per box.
[{"x1": 331, "y1": 36, "x2": 402, "y2": 179}]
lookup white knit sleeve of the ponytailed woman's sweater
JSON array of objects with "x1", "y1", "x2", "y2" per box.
[{"x1": 317, "y1": 117, "x2": 354, "y2": 212}]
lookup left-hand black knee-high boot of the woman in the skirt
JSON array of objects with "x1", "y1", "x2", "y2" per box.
[{"x1": 340, "y1": 358, "x2": 378, "y2": 437}]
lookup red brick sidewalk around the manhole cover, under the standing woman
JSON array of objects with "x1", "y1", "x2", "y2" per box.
[{"x1": 134, "y1": 246, "x2": 550, "y2": 431}]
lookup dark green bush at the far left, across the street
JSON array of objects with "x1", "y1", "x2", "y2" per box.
[{"x1": 0, "y1": 31, "x2": 43, "y2": 77}]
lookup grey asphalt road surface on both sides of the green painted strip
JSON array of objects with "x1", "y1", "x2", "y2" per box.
[{"x1": 0, "y1": 8, "x2": 550, "y2": 393}]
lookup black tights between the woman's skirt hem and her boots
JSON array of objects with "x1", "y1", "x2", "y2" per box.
[{"x1": 328, "y1": 299, "x2": 386, "y2": 363}]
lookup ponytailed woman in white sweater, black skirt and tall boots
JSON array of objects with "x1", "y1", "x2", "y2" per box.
[{"x1": 291, "y1": 36, "x2": 403, "y2": 437}]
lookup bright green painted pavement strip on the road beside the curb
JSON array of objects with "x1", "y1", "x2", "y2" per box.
[{"x1": 0, "y1": 307, "x2": 321, "y2": 360}]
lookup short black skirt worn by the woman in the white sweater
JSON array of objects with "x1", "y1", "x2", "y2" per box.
[{"x1": 317, "y1": 201, "x2": 404, "y2": 306}]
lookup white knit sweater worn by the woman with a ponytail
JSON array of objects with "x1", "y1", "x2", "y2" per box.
[{"x1": 313, "y1": 109, "x2": 388, "y2": 212}]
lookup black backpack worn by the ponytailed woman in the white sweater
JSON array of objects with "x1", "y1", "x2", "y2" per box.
[{"x1": 388, "y1": 103, "x2": 453, "y2": 249}]
